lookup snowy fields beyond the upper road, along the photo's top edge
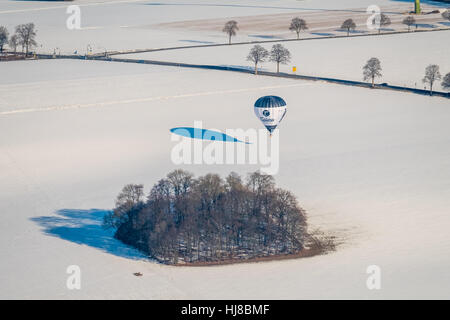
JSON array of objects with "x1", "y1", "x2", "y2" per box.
[{"x1": 0, "y1": 0, "x2": 448, "y2": 54}]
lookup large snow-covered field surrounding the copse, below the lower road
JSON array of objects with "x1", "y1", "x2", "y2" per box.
[{"x1": 0, "y1": 60, "x2": 450, "y2": 299}]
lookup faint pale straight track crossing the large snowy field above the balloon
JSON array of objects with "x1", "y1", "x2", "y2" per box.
[{"x1": 0, "y1": 83, "x2": 312, "y2": 116}]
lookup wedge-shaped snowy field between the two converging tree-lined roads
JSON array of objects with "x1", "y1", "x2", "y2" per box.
[{"x1": 122, "y1": 30, "x2": 450, "y2": 90}]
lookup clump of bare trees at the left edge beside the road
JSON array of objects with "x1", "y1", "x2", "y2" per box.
[{"x1": 0, "y1": 23, "x2": 37, "y2": 56}]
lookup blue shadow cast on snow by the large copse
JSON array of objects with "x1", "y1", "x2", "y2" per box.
[{"x1": 30, "y1": 209, "x2": 146, "y2": 259}]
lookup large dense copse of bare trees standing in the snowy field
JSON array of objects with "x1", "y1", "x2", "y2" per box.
[{"x1": 104, "y1": 170, "x2": 316, "y2": 264}]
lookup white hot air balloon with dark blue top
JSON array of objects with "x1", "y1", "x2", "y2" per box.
[{"x1": 255, "y1": 96, "x2": 287, "y2": 135}]
